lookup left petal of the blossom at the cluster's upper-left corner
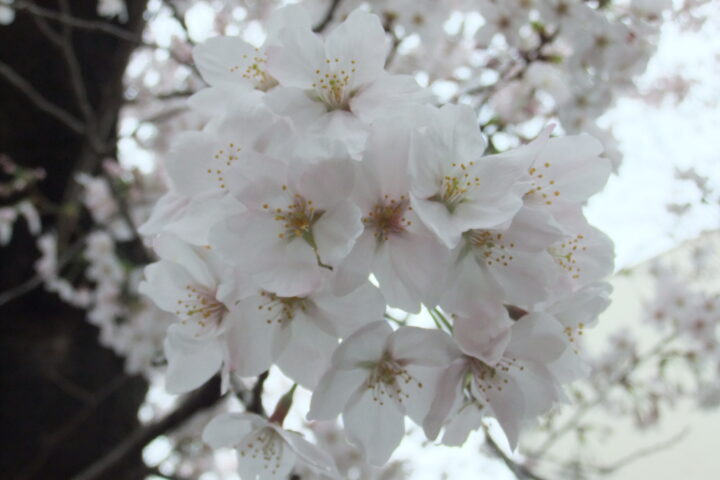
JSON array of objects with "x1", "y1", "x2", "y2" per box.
[{"x1": 193, "y1": 36, "x2": 257, "y2": 88}]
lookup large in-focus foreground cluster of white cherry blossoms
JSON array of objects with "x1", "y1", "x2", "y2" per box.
[{"x1": 140, "y1": 6, "x2": 613, "y2": 478}]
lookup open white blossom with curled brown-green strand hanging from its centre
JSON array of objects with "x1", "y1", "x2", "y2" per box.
[{"x1": 211, "y1": 153, "x2": 362, "y2": 297}]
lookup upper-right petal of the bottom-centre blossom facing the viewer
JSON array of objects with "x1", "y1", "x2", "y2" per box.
[{"x1": 388, "y1": 327, "x2": 460, "y2": 367}]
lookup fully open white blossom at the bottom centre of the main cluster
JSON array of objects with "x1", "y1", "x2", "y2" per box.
[{"x1": 308, "y1": 322, "x2": 457, "y2": 465}]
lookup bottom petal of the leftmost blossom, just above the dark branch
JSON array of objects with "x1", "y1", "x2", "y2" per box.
[{"x1": 165, "y1": 325, "x2": 223, "y2": 394}]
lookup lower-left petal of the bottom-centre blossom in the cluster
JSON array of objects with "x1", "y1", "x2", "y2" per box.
[{"x1": 307, "y1": 363, "x2": 368, "y2": 420}]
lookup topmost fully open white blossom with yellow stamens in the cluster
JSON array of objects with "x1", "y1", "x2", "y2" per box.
[{"x1": 265, "y1": 10, "x2": 424, "y2": 153}]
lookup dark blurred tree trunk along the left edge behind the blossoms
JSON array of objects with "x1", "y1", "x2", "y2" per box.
[{"x1": 0, "y1": 0, "x2": 147, "y2": 479}]
